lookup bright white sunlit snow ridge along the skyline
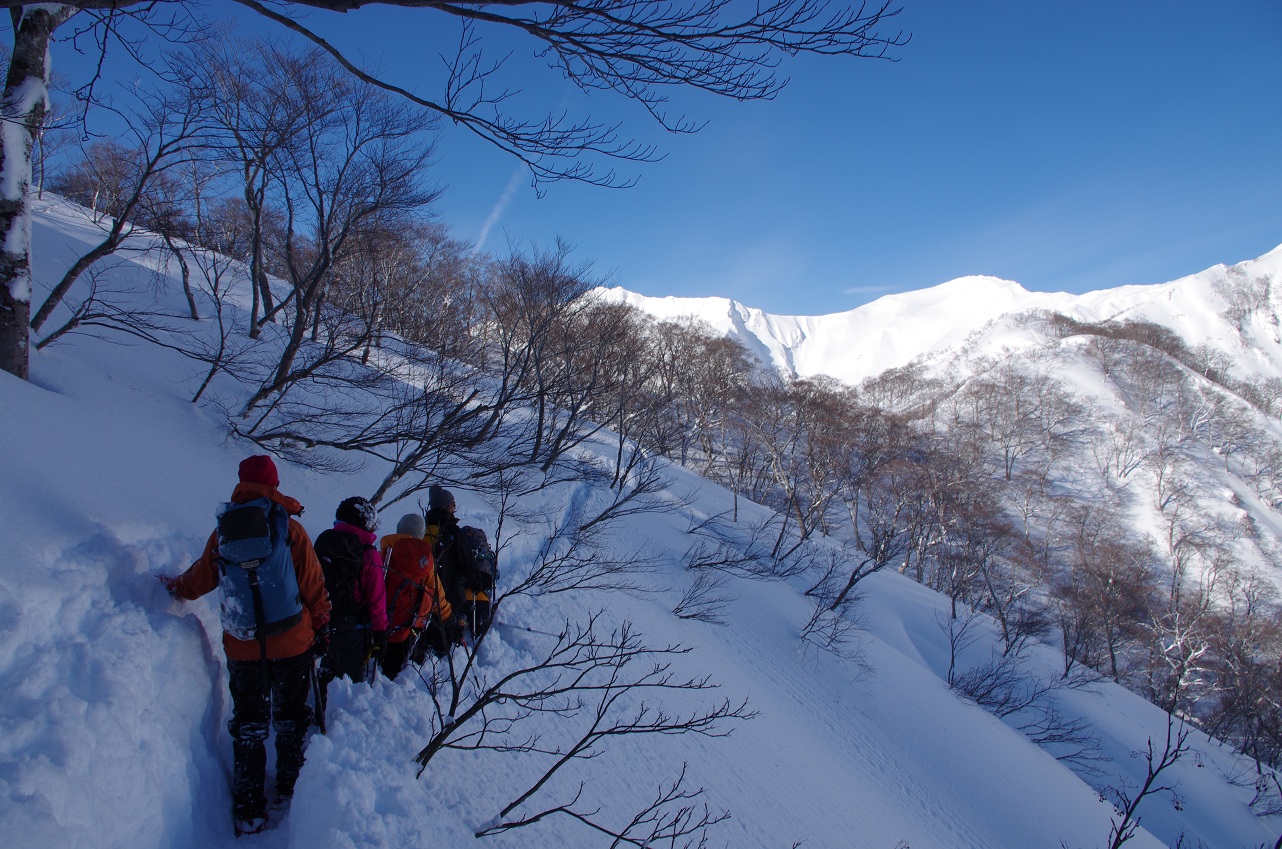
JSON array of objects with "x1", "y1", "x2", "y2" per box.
[{"x1": 600, "y1": 239, "x2": 1282, "y2": 385}]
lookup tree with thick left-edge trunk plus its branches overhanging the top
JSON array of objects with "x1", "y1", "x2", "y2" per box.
[{"x1": 0, "y1": 0, "x2": 906, "y2": 377}]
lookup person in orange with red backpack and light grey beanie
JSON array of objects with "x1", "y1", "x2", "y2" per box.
[{"x1": 378, "y1": 513, "x2": 456, "y2": 678}]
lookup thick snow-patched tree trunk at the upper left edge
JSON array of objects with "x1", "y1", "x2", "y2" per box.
[{"x1": 0, "y1": 5, "x2": 77, "y2": 380}]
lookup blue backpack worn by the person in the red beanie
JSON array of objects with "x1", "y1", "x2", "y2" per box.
[{"x1": 218, "y1": 498, "x2": 303, "y2": 646}]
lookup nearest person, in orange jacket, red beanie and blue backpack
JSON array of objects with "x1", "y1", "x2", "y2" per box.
[{"x1": 160, "y1": 455, "x2": 329, "y2": 834}]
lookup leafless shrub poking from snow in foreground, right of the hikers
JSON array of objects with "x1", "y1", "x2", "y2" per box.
[{"x1": 414, "y1": 614, "x2": 754, "y2": 846}]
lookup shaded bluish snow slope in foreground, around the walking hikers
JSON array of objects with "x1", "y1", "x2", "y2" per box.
[{"x1": 0, "y1": 205, "x2": 1282, "y2": 849}]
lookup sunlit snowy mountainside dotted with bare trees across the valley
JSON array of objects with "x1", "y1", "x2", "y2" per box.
[{"x1": 606, "y1": 250, "x2": 1282, "y2": 763}]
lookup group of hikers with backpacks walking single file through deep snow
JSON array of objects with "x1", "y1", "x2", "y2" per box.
[{"x1": 160, "y1": 454, "x2": 497, "y2": 835}]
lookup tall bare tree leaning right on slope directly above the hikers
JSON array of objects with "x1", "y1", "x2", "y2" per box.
[{"x1": 187, "y1": 45, "x2": 436, "y2": 428}]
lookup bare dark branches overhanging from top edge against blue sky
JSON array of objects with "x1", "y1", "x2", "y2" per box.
[{"x1": 241, "y1": 0, "x2": 906, "y2": 185}]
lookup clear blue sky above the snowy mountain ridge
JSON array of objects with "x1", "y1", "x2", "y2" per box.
[{"x1": 45, "y1": 0, "x2": 1282, "y2": 314}]
